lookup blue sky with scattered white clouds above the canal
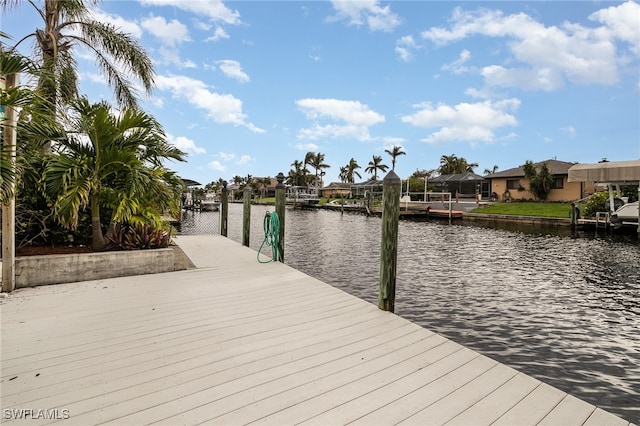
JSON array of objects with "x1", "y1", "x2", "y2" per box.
[{"x1": 1, "y1": 0, "x2": 640, "y2": 184}]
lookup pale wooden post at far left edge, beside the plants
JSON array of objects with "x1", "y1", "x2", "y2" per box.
[{"x1": 2, "y1": 74, "x2": 18, "y2": 293}]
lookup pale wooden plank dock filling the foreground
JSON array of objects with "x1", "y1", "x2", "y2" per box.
[{"x1": 0, "y1": 236, "x2": 629, "y2": 425}]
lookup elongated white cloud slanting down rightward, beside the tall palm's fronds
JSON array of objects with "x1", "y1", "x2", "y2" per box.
[{"x1": 156, "y1": 75, "x2": 264, "y2": 133}]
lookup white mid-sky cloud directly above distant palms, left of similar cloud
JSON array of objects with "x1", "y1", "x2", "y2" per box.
[{"x1": 296, "y1": 99, "x2": 385, "y2": 141}]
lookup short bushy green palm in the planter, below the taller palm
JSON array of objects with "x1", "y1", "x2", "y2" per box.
[{"x1": 45, "y1": 98, "x2": 185, "y2": 250}]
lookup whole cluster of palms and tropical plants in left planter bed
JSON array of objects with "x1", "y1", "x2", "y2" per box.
[{"x1": 0, "y1": 0, "x2": 186, "y2": 250}]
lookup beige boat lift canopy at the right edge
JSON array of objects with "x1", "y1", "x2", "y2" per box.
[{"x1": 569, "y1": 160, "x2": 640, "y2": 184}]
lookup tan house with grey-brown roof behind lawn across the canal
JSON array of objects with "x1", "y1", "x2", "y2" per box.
[{"x1": 485, "y1": 159, "x2": 585, "y2": 201}]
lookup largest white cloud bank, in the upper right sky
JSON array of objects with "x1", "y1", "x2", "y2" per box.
[{"x1": 422, "y1": 2, "x2": 640, "y2": 90}]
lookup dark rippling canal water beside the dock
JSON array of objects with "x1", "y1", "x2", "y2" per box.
[{"x1": 178, "y1": 204, "x2": 640, "y2": 423}]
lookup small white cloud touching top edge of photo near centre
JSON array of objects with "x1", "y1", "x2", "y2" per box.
[{"x1": 327, "y1": 0, "x2": 401, "y2": 32}]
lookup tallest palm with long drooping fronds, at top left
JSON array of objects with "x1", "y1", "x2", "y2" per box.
[{"x1": 0, "y1": 0, "x2": 155, "y2": 149}]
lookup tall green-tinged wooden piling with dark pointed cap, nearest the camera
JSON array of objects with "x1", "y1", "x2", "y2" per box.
[{"x1": 378, "y1": 170, "x2": 402, "y2": 312}]
